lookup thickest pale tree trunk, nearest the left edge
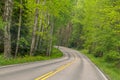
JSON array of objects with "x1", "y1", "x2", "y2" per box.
[{"x1": 3, "y1": 0, "x2": 13, "y2": 58}]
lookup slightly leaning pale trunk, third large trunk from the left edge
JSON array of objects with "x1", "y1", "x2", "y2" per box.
[{"x1": 30, "y1": 0, "x2": 39, "y2": 56}]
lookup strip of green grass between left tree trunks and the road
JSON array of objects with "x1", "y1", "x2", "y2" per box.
[{"x1": 0, "y1": 48, "x2": 63, "y2": 66}]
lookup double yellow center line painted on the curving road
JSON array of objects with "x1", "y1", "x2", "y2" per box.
[{"x1": 35, "y1": 59, "x2": 76, "y2": 80}]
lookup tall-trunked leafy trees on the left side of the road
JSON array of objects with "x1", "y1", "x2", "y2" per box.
[{"x1": 0, "y1": 0, "x2": 74, "y2": 59}]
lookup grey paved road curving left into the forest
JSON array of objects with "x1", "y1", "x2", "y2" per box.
[{"x1": 0, "y1": 47, "x2": 107, "y2": 80}]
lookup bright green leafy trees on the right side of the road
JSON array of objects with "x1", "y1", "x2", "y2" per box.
[{"x1": 71, "y1": 0, "x2": 120, "y2": 62}]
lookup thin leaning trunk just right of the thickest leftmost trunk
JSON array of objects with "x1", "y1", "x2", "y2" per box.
[{"x1": 15, "y1": 0, "x2": 22, "y2": 57}]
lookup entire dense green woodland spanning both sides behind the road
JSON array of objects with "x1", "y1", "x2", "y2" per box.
[{"x1": 0, "y1": 0, "x2": 120, "y2": 66}]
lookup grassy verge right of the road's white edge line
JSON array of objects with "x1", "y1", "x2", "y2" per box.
[{"x1": 81, "y1": 50, "x2": 120, "y2": 80}]
